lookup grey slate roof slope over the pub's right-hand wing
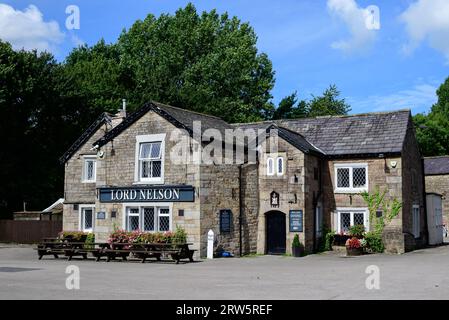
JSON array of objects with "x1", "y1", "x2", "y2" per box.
[{"x1": 276, "y1": 110, "x2": 410, "y2": 157}]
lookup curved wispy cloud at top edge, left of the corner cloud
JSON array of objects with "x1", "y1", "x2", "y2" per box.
[{"x1": 327, "y1": 0, "x2": 376, "y2": 52}]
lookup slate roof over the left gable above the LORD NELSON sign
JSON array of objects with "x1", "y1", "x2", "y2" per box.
[{"x1": 94, "y1": 101, "x2": 232, "y2": 147}]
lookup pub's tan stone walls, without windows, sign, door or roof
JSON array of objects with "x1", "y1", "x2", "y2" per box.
[{"x1": 63, "y1": 107, "x2": 427, "y2": 257}]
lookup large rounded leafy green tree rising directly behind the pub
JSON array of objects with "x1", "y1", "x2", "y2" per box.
[{"x1": 117, "y1": 4, "x2": 274, "y2": 122}]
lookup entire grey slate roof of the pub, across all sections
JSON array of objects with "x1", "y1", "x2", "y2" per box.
[{"x1": 61, "y1": 102, "x2": 411, "y2": 163}]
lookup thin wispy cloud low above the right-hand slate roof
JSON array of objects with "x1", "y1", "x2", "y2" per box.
[{"x1": 348, "y1": 84, "x2": 437, "y2": 112}]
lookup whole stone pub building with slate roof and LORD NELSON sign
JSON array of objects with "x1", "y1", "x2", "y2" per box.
[{"x1": 61, "y1": 102, "x2": 427, "y2": 256}]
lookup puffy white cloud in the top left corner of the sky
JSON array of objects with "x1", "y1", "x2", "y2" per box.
[{"x1": 0, "y1": 4, "x2": 64, "y2": 51}]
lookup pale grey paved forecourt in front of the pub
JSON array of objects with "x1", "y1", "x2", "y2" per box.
[{"x1": 0, "y1": 245, "x2": 449, "y2": 300}]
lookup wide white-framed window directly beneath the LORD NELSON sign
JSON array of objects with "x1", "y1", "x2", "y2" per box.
[{"x1": 125, "y1": 204, "x2": 172, "y2": 232}]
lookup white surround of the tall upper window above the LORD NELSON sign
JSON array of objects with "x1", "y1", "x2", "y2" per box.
[{"x1": 134, "y1": 133, "x2": 166, "y2": 184}]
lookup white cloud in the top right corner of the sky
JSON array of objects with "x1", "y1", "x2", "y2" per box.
[{"x1": 400, "y1": 0, "x2": 449, "y2": 63}]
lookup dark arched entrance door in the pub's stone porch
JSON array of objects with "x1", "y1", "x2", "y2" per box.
[{"x1": 266, "y1": 211, "x2": 285, "y2": 254}]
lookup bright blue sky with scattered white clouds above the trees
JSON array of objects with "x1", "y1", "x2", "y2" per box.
[{"x1": 0, "y1": 0, "x2": 449, "y2": 113}]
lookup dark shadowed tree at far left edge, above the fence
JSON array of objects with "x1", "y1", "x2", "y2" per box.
[{"x1": 0, "y1": 41, "x2": 82, "y2": 217}]
